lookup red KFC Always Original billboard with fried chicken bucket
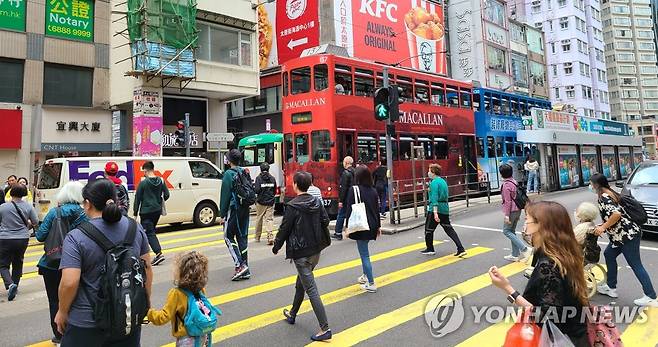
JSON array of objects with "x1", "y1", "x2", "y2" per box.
[{"x1": 334, "y1": 0, "x2": 448, "y2": 75}]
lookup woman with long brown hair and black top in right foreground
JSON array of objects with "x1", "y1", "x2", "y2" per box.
[{"x1": 489, "y1": 201, "x2": 590, "y2": 347}]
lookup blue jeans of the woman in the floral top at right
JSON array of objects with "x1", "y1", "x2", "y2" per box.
[{"x1": 603, "y1": 235, "x2": 656, "y2": 299}]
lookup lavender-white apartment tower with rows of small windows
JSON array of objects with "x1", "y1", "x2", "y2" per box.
[{"x1": 510, "y1": 0, "x2": 610, "y2": 119}]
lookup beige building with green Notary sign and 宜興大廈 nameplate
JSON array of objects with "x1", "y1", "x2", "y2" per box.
[{"x1": 0, "y1": 0, "x2": 112, "y2": 183}]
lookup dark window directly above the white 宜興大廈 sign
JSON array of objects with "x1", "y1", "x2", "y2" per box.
[{"x1": 43, "y1": 63, "x2": 94, "y2": 107}]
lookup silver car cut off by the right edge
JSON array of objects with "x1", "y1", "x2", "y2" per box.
[{"x1": 615, "y1": 160, "x2": 658, "y2": 235}]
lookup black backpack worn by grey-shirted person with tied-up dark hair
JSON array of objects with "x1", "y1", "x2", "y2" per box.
[{"x1": 78, "y1": 218, "x2": 149, "y2": 339}]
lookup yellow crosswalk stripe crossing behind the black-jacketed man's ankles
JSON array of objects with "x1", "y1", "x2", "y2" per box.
[{"x1": 165, "y1": 247, "x2": 492, "y2": 347}]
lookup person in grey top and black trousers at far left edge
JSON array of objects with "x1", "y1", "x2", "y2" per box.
[{"x1": 0, "y1": 183, "x2": 39, "y2": 301}]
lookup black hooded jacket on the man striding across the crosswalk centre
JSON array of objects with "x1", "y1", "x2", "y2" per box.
[{"x1": 272, "y1": 194, "x2": 331, "y2": 259}]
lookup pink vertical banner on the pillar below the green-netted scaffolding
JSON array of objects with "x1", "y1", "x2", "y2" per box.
[{"x1": 133, "y1": 87, "x2": 163, "y2": 157}]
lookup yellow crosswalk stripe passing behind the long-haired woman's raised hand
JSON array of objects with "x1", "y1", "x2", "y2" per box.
[{"x1": 304, "y1": 262, "x2": 526, "y2": 346}]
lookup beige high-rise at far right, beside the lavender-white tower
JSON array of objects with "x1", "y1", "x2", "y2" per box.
[{"x1": 601, "y1": 0, "x2": 658, "y2": 155}]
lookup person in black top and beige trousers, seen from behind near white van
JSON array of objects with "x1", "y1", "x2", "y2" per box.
[{"x1": 254, "y1": 163, "x2": 277, "y2": 246}]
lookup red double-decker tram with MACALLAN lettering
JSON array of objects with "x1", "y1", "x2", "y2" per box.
[{"x1": 281, "y1": 55, "x2": 475, "y2": 214}]
